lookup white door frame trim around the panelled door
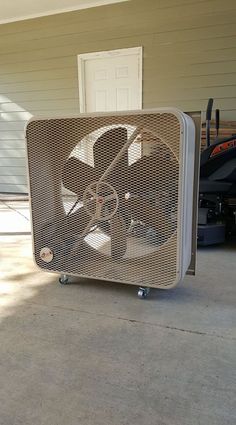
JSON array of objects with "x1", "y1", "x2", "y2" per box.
[{"x1": 77, "y1": 46, "x2": 143, "y2": 113}]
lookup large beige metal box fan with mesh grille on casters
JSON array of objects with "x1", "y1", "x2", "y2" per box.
[{"x1": 26, "y1": 108, "x2": 195, "y2": 298}]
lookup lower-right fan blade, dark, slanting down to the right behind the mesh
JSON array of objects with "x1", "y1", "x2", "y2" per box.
[{"x1": 127, "y1": 197, "x2": 173, "y2": 237}]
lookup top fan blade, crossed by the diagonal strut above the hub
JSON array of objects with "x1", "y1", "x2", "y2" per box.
[{"x1": 93, "y1": 127, "x2": 128, "y2": 180}]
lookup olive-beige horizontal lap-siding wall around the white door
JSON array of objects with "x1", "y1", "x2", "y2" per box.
[{"x1": 0, "y1": 0, "x2": 236, "y2": 192}]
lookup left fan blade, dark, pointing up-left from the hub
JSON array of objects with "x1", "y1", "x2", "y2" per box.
[{"x1": 62, "y1": 157, "x2": 96, "y2": 197}]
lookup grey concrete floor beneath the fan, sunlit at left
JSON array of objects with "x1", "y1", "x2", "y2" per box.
[{"x1": 0, "y1": 201, "x2": 236, "y2": 425}]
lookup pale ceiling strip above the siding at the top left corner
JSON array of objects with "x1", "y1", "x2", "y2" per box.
[{"x1": 0, "y1": 0, "x2": 127, "y2": 24}]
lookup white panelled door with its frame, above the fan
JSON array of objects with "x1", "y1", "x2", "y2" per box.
[{"x1": 78, "y1": 47, "x2": 142, "y2": 112}]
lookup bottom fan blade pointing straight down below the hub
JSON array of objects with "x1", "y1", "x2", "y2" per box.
[{"x1": 110, "y1": 213, "x2": 127, "y2": 260}]
